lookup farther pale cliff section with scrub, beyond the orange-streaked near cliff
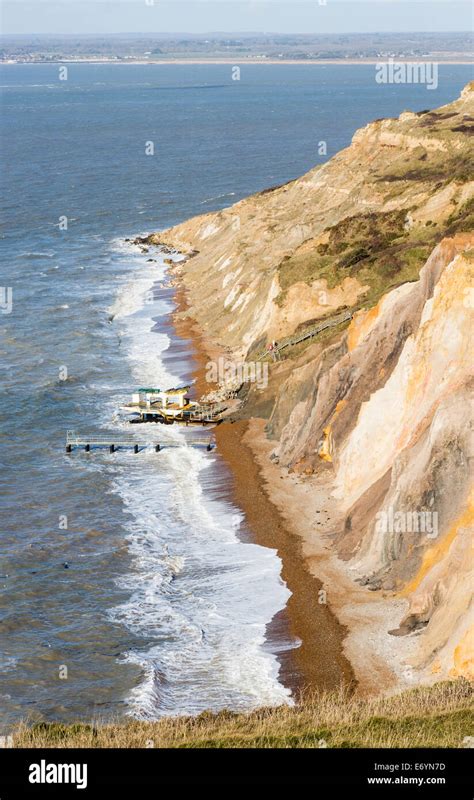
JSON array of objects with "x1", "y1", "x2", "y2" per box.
[{"x1": 153, "y1": 83, "x2": 474, "y2": 355}]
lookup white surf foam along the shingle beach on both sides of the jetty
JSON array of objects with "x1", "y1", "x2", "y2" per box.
[{"x1": 111, "y1": 239, "x2": 291, "y2": 719}]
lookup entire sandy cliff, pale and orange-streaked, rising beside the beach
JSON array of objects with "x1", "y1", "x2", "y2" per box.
[{"x1": 150, "y1": 85, "x2": 474, "y2": 691}]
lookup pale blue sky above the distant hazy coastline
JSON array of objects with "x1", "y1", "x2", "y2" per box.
[{"x1": 0, "y1": 0, "x2": 473, "y2": 34}]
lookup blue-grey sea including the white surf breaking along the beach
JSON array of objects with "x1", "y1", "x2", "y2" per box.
[{"x1": 0, "y1": 65, "x2": 469, "y2": 726}]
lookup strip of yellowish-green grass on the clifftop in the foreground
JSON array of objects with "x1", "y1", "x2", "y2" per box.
[{"x1": 13, "y1": 680, "x2": 474, "y2": 748}]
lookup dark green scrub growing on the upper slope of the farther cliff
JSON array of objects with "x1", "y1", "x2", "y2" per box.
[{"x1": 277, "y1": 101, "x2": 474, "y2": 310}]
